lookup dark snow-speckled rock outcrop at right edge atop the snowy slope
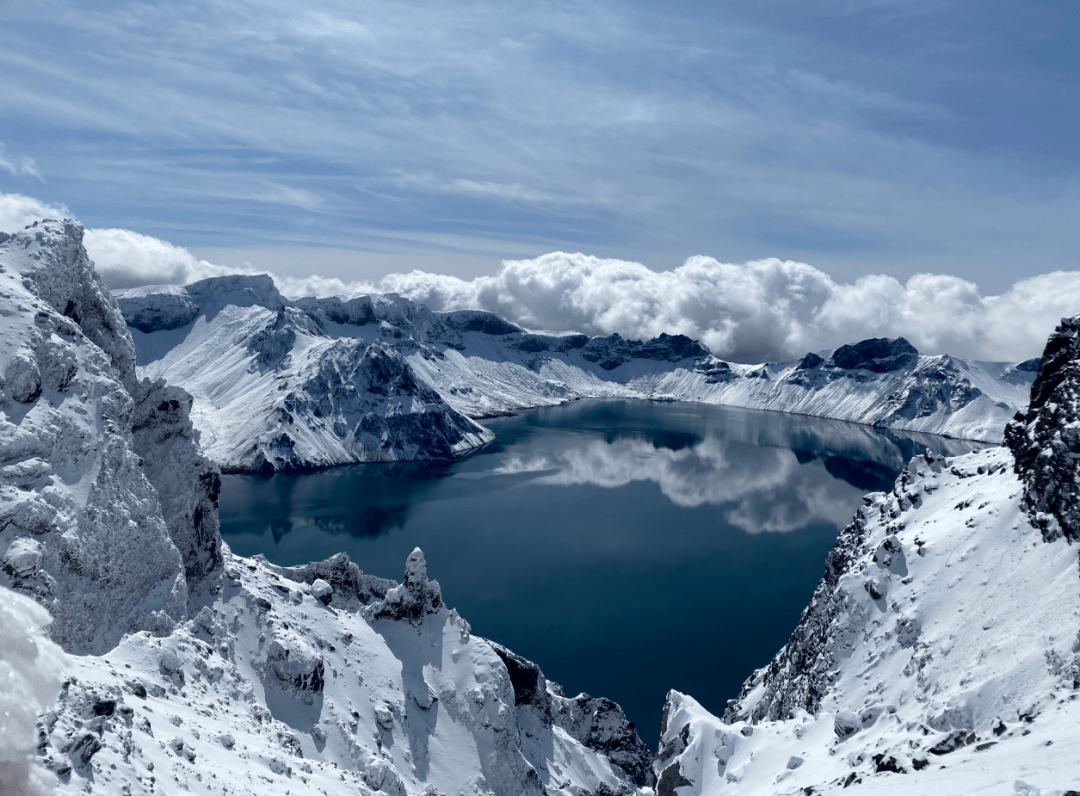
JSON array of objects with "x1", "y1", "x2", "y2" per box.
[{"x1": 1005, "y1": 315, "x2": 1080, "y2": 541}]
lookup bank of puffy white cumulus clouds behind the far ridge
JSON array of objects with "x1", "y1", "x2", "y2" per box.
[{"x1": 6, "y1": 193, "x2": 1080, "y2": 362}]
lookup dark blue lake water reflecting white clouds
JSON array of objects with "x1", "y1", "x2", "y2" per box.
[{"x1": 220, "y1": 401, "x2": 982, "y2": 747}]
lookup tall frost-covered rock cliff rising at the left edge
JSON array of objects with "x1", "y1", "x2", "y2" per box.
[{"x1": 0, "y1": 221, "x2": 220, "y2": 652}]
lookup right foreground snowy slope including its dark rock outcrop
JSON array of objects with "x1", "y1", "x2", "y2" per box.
[{"x1": 653, "y1": 318, "x2": 1080, "y2": 796}]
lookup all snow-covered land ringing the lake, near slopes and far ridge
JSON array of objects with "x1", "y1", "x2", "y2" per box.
[{"x1": 0, "y1": 221, "x2": 1080, "y2": 796}]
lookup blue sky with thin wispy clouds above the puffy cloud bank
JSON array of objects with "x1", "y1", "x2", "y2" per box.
[{"x1": 0, "y1": 0, "x2": 1080, "y2": 294}]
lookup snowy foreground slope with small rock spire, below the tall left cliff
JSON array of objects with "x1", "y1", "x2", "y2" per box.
[{"x1": 41, "y1": 551, "x2": 651, "y2": 796}]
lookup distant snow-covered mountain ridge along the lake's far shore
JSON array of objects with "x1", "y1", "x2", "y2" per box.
[{"x1": 117, "y1": 276, "x2": 1035, "y2": 471}]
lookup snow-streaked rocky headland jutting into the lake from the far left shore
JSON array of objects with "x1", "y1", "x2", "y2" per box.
[{"x1": 115, "y1": 276, "x2": 494, "y2": 474}]
